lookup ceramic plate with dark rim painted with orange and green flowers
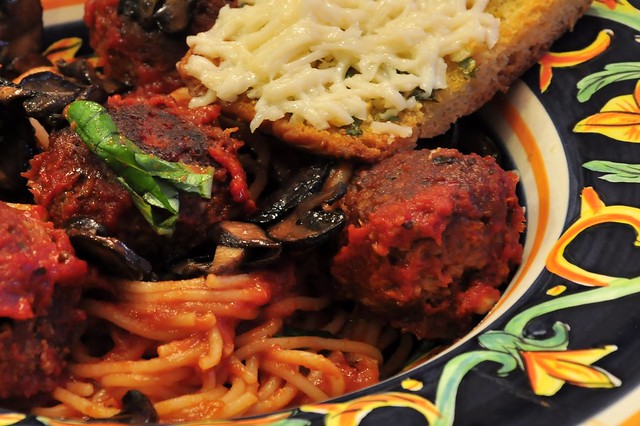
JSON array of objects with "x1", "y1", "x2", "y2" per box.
[{"x1": 0, "y1": 0, "x2": 640, "y2": 426}]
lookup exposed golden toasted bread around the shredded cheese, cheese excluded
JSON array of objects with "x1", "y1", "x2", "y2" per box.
[{"x1": 178, "y1": 0, "x2": 592, "y2": 162}]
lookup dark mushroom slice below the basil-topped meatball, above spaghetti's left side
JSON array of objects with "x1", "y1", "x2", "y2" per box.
[{"x1": 66, "y1": 218, "x2": 153, "y2": 280}]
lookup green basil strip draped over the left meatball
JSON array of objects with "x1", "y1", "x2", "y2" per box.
[{"x1": 64, "y1": 101, "x2": 214, "y2": 235}]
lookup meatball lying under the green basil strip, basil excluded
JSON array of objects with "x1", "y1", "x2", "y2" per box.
[{"x1": 26, "y1": 95, "x2": 254, "y2": 268}]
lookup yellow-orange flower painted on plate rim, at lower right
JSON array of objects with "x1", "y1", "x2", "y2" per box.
[{"x1": 520, "y1": 345, "x2": 621, "y2": 396}]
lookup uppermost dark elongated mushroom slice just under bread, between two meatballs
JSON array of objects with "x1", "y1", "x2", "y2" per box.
[{"x1": 249, "y1": 161, "x2": 331, "y2": 225}]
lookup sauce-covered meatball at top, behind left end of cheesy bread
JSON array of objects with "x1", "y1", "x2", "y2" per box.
[{"x1": 84, "y1": 0, "x2": 236, "y2": 93}]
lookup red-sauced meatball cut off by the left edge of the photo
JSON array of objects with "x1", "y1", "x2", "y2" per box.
[{"x1": 0, "y1": 202, "x2": 88, "y2": 398}]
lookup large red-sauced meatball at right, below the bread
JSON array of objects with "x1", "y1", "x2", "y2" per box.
[{"x1": 331, "y1": 149, "x2": 524, "y2": 338}]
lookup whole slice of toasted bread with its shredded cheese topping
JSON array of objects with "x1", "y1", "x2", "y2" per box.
[{"x1": 179, "y1": 0, "x2": 590, "y2": 161}]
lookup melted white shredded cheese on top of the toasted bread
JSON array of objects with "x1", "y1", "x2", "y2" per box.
[{"x1": 183, "y1": 0, "x2": 499, "y2": 136}]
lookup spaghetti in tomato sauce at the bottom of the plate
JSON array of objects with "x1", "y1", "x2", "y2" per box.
[{"x1": 35, "y1": 267, "x2": 412, "y2": 422}]
